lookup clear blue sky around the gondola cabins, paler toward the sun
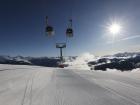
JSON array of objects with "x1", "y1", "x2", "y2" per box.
[{"x1": 0, "y1": 0, "x2": 140, "y2": 56}]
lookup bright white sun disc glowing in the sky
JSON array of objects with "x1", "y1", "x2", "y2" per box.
[{"x1": 108, "y1": 23, "x2": 121, "y2": 35}]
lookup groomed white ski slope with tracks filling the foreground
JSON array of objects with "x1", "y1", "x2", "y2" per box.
[{"x1": 0, "y1": 65, "x2": 140, "y2": 105}]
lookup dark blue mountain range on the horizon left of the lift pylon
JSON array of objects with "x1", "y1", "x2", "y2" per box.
[{"x1": 0, "y1": 56, "x2": 60, "y2": 67}]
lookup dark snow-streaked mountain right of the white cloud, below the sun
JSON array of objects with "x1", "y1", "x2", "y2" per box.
[{"x1": 88, "y1": 52, "x2": 140, "y2": 71}]
